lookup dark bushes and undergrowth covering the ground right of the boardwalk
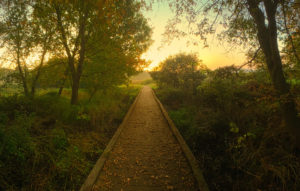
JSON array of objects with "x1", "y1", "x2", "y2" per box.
[{"x1": 156, "y1": 67, "x2": 300, "y2": 190}]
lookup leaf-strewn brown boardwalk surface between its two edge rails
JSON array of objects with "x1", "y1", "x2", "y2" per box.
[{"x1": 93, "y1": 87, "x2": 197, "y2": 191}]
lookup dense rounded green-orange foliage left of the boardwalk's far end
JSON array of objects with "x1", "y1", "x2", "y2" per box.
[{"x1": 83, "y1": 1, "x2": 152, "y2": 101}]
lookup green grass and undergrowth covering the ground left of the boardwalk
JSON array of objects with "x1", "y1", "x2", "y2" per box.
[{"x1": 0, "y1": 86, "x2": 139, "y2": 190}]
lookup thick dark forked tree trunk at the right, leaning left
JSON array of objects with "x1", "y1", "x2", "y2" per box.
[{"x1": 248, "y1": 0, "x2": 300, "y2": 147}]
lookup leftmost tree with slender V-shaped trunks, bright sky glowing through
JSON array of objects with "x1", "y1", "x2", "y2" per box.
[{"x1": 0, "y1": 0, "x2": 55, "y2": 97}]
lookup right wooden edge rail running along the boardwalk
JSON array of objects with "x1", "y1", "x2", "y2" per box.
[{"x1": 151, "y1": 88, "x2": 209, "y2": 191}]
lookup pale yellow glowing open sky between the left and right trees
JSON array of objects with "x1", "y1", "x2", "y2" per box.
[{"x1": 142, "y1": 2, "x2": 246, "y2": 70}]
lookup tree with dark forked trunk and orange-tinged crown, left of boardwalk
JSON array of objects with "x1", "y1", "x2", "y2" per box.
[{"x1": 53, "y1": 0, "x2": 150, "y2": 104}]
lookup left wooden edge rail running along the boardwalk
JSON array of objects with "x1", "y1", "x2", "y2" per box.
[{"x1": 80, "y1": 87, "x2": 143, "y2": 191}]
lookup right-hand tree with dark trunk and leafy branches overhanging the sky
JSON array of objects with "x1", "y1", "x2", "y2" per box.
[{"x1": 166, "y1": 0, "x2": 300, "y2": 149}]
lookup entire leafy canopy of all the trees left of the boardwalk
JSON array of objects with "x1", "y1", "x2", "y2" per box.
[{"x1": 0, "y1": 0, "x2": 152, "y2": 104}]
